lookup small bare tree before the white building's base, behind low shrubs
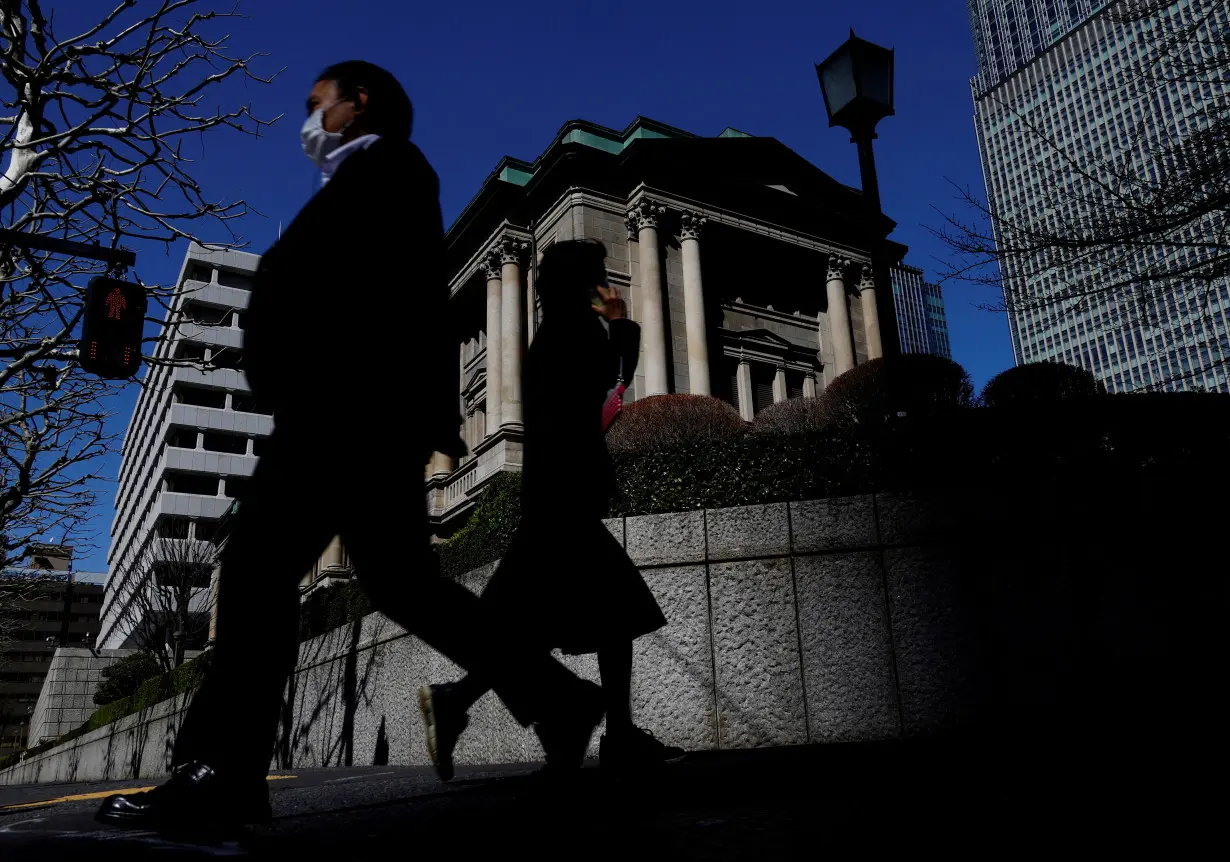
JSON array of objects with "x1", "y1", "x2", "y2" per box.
[{"x1": 116, "y1": 530, "x2": 218, "y2": 670}]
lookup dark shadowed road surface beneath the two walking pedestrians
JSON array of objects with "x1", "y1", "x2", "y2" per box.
[{"x1": 0, "y1": 743, "x2": 1220, "y2": 862}]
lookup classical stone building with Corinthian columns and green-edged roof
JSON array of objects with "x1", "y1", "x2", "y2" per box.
[{"x1": 427, "y1": 118, "x2": 905, "y2": 532}]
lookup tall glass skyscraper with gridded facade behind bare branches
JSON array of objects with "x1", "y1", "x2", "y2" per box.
[{"x1": 968, "y1": 0, "x2": 1230, "y2": 392}]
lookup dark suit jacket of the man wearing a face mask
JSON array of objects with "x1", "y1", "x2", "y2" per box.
[{"x1": 244, "y1": 138, "x2": 460, "y2": 459}]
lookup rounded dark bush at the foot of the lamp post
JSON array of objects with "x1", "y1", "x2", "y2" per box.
[{"x1": 819, "y1": 353, "x2": 974, "y2": 429}]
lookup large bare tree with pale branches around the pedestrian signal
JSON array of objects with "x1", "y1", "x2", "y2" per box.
[{"x1": 0, "y1": 0, "x2": 279, "y2": 564}]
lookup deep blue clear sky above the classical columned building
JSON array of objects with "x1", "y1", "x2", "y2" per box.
[{"x1": 62, "y1": 0, "x2": 1012, "y2": 569}]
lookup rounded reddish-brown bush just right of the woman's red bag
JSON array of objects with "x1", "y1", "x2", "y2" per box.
[{"x1": 606, "y1": 395, "x2": 748, "y2": 453}]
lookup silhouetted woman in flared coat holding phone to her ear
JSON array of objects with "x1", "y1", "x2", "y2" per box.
[{"x1": 419, "y1": 240, "x2": 684, "y2": 781}]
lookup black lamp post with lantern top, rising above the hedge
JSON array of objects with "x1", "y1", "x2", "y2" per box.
[{"x1": 815, "y1": 28, "x2": 902, "y2": 355}]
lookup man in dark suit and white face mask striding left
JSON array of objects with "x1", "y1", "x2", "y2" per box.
[{"x1": 98, "y1": 61, "x2": 601, "y2": 828}]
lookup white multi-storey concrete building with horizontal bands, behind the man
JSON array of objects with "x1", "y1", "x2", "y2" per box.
[{"x1": 97, "y1": 243, "x2": 273, "y2": 649}]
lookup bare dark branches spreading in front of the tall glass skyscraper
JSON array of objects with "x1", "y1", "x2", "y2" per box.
[{"x1": 936, "y1": 0, "x2": 1230, "y2": 387}]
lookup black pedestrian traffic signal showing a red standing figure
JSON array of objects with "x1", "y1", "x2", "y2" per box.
[{"x1": 77, "y1": 275, "x2": 146, "y2": 380}]
